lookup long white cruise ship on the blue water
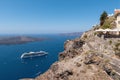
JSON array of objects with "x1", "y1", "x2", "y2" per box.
[{"x1": 21, "y1": 51, "x2": 48, "y2": 59}]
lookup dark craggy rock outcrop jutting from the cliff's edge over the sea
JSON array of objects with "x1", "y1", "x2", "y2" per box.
[{"x1": 59, "y1": 39, "x2": 85, "y2": 60}]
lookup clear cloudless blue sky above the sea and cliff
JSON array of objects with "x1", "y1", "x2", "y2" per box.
[{"x1": 0, "y1": 0, "x2": 120, "y2": 34}]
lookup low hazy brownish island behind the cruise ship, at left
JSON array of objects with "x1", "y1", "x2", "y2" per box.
[{"x1": 0, "y1": 36, "x2": 45, "y2": 45}]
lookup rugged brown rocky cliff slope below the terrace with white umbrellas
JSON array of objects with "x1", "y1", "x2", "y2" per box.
[{"x1": 32, "y1": 26, "x2": 120, "y2": 80}]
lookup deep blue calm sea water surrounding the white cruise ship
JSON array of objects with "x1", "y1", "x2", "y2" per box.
[{"x1": 0, "y1": 35, "x2": 79, "y2": 80}]
